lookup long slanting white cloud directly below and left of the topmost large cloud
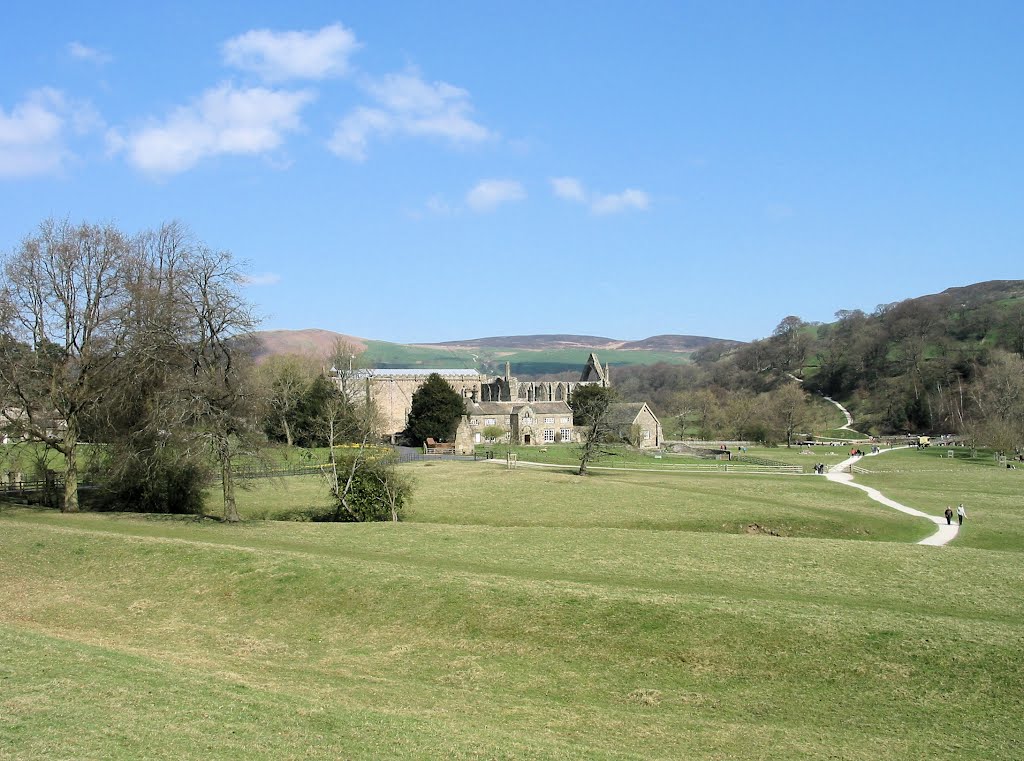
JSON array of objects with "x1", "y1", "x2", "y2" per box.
[{"x1": 117, "y1": 84, "x2": 315, "y2": 174}]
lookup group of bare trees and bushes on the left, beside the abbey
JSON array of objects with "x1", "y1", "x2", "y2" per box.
[{"x1": 0, "y1": 219, "x2": 408, "y2": 521}]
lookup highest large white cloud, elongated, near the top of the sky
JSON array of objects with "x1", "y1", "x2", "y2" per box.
[{"x1": 221, "y1": 24, "x2": 359, "y2": 82}]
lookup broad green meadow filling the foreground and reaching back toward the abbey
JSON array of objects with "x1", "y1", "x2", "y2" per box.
[{"x1": 0, "y1": 452, "x2": 1024, "y2": 761}]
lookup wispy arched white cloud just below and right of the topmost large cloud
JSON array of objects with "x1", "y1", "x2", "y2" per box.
[{"x1": 328, "y1": 70, "x2": 494, "y2": 161}]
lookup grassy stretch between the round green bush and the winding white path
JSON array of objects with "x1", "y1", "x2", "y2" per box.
[{"x1": 408, "y1": 462, "x2": 933, "y2": 542}]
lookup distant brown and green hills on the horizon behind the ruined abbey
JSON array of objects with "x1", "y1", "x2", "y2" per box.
[{"x1": 250, "y1": 329, "x2": 741, "y2": 376}]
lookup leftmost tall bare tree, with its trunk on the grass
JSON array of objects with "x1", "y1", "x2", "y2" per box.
[{"x1": 0, "y1": 219, "x2": 133, "y2": 512}]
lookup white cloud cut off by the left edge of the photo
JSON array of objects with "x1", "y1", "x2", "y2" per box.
[{"x1": 0, "y1": 88, "x2": 102, "y2": 177}]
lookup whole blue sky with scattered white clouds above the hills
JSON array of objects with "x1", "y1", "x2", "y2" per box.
[{"x1": 0, "y1": 1, "x2": 1024, "y2": 342}]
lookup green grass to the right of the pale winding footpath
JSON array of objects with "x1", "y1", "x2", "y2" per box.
[{"x1": 857, "y1": 447, "x2": 1024, "y2": 552}]
